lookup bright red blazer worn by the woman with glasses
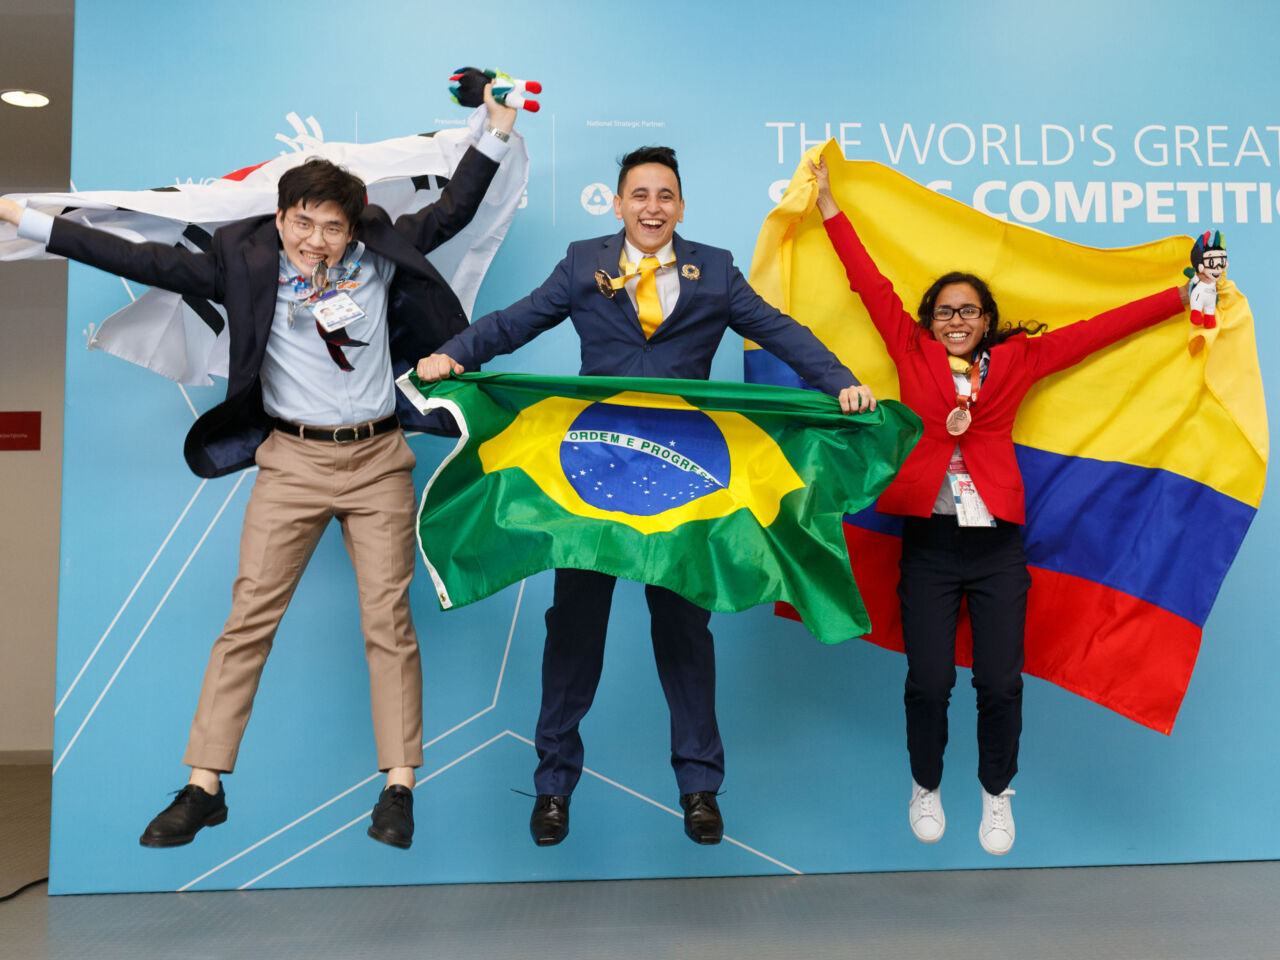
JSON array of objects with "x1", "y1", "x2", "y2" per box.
[{"x1": 824, "y1": 214, "x2": 1184, "y2": 524}]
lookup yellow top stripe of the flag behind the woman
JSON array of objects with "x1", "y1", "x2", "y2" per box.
[{"x1": 748, "y1": 141, "x2": 1268, "y2": 507}]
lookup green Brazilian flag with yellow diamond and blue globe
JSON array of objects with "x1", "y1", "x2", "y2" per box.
[{"x1": 401, "y1": 374, "x2": 922, "y2": 643}]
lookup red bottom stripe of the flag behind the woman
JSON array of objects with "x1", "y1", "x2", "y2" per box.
[{"x1": 774, "y1": 524, "x2": 1201, "y2": 733}]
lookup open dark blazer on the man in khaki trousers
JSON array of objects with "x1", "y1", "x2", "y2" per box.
[{"x1": 49, "y1": 147, "x2": 498, "y2": 477}]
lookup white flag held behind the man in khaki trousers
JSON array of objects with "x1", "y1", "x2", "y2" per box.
[{"x1": 0, "y1": 108, "x2": 529, "y2": 385}]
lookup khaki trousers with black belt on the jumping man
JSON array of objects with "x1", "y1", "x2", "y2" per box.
[{"x1": 183, "y1": 430, "x2": 422, "y2": 773}]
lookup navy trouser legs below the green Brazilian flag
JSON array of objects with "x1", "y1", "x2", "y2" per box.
[{"x1": 534, "y1": 570, "x2": 724, "y2": 795}]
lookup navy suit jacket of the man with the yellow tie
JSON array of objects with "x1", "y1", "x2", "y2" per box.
[{"x1": 438, "y1": 233, "x2": 858, "y2": 394}]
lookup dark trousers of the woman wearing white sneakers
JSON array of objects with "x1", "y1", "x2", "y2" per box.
[{"x1": 897, "y1": 516, "x2": 1032, "y2": 794}]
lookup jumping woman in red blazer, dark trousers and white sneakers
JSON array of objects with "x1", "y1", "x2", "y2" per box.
[{"x1": 810, "y1": 160, "x2": 1187, "y2": 855}]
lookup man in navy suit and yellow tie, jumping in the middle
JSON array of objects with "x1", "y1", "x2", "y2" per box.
[{"x1": 417, "y1": 147, "x2": 876, "y2": 846}]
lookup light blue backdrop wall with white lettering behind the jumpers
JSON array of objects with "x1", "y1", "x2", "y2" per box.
[{"x1": 50, "y1": 0, "x2": 1280, "y2": 893}]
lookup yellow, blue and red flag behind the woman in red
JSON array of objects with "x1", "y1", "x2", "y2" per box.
[{"x1": 745, "y1": 141, "x2": 1268, "y2": 733}]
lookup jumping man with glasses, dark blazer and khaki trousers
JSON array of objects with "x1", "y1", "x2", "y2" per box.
[{"x1": 0, "y1": 87, "x2": 516, "y2": 849}]
